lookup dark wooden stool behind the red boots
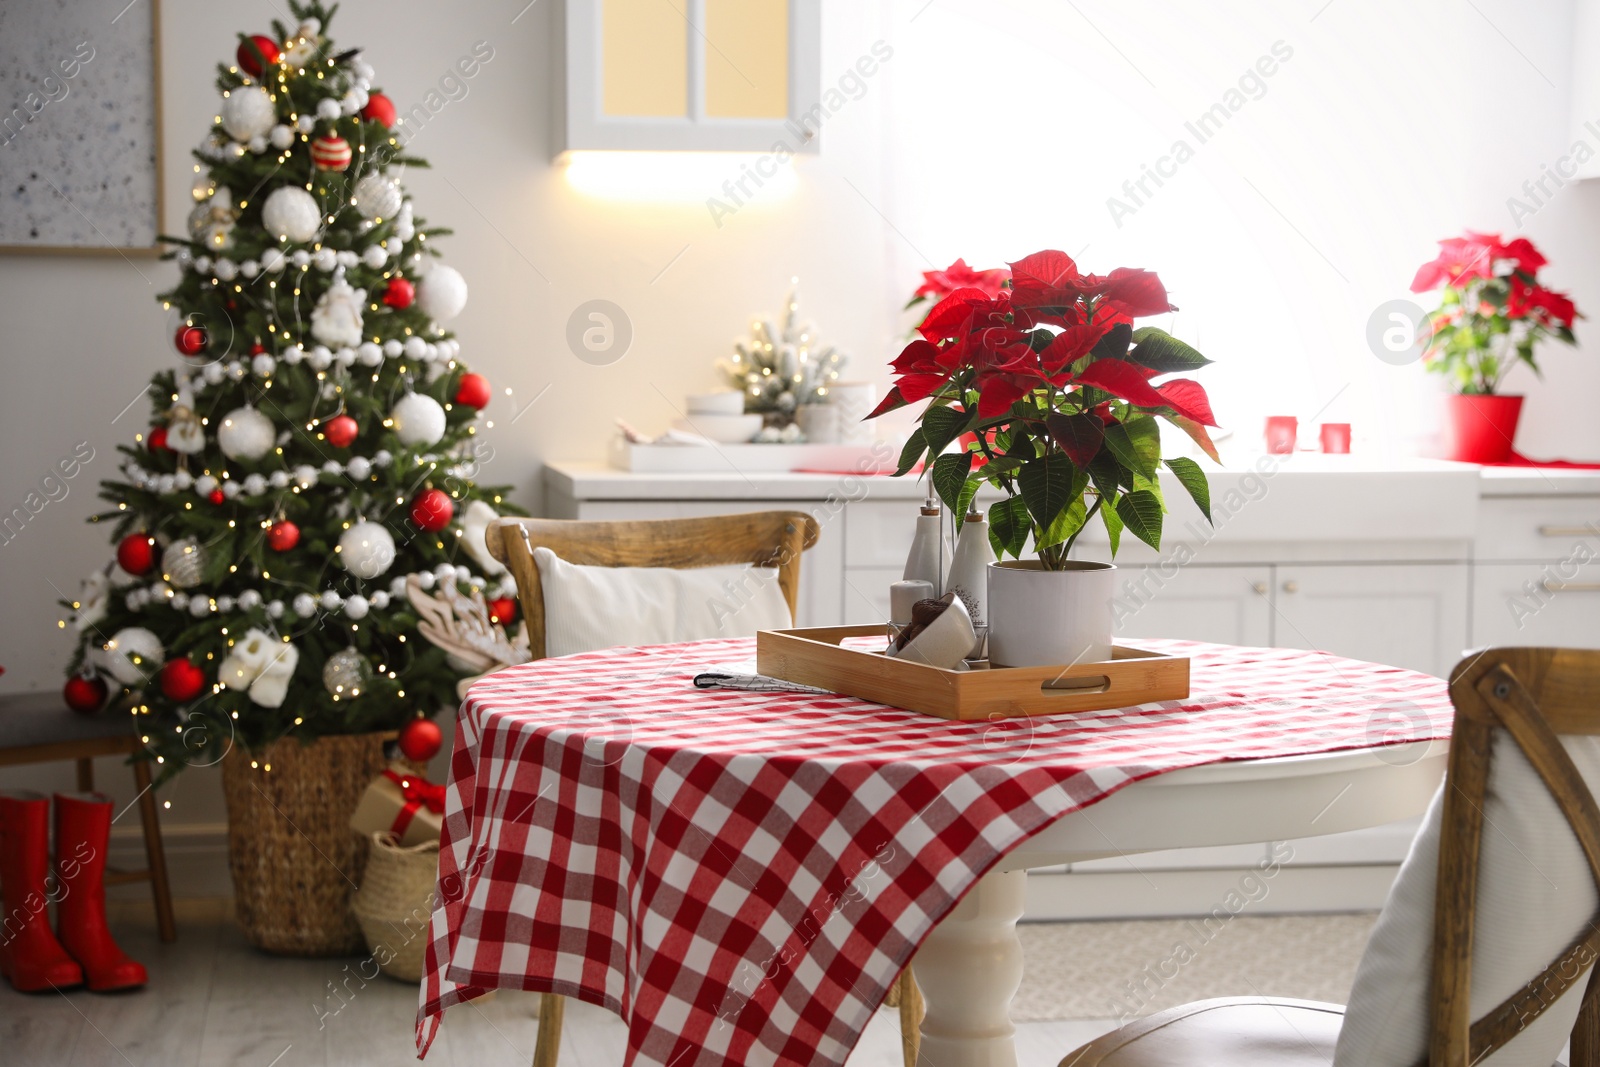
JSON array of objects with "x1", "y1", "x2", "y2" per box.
[{"x1": 0, "y1": 693, "x2": 178, "y2": 941}]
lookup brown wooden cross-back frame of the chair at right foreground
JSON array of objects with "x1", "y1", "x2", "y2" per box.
[{"x1": 1429, "y1": 648, "x2": 1600, "y2": 1067}]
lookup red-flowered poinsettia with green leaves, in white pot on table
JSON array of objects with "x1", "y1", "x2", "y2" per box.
[{"x1": 869, "y1": 251, "x2": 1216, "y2": 569}]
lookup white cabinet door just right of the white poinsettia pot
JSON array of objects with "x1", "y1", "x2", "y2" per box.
[{"x1": 1115, "y1": 565, "x2": 1272, "y2": 645}]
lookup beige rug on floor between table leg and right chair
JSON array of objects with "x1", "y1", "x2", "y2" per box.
[{"x1": 1011, "y1": 913, "x2": 1378, "y2": 1022}]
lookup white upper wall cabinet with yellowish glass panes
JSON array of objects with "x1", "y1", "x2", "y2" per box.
[{"x1": 555, "y1": 0, "x2": 822, "y2": 155}]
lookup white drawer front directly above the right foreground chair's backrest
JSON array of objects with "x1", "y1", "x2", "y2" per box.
[{"x1": 1472, "y1": 560, "x2": 1600, "y2": 648}]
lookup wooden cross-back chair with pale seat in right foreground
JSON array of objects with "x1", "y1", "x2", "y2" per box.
[{"x1": 1061, "y1": 648, "x2": 1600, "y2": 1067}]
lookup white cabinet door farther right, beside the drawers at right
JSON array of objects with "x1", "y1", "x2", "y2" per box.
[{"x1": 1274, "y1": 563, "x2": 1469, "y2": 677}]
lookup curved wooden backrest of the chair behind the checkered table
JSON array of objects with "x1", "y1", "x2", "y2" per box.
[{"x1": 486, "y1": 512, "x2": 819, "y2": 659}]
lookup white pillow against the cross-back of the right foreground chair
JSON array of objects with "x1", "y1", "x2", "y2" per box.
[{"x1": 1333, "y1": 731, "x2": 1600, "y2": 1067}]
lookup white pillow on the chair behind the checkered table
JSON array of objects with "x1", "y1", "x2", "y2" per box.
[{"x1": 533, "y1": 547, "x2": 792, "y2": 656}]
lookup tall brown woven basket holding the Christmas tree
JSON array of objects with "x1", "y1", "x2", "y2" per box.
[{"x1": 222, "y1": 733, "x2": 394, "y2": 957}]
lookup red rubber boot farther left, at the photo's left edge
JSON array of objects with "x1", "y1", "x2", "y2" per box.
[{"x1": 0, "y1": 792, "x2": 83, "y2": 993}]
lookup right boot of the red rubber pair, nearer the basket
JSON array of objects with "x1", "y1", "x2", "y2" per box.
[{"x1": 56, "y1": 793, "x2": 146, "y2": 993}]
